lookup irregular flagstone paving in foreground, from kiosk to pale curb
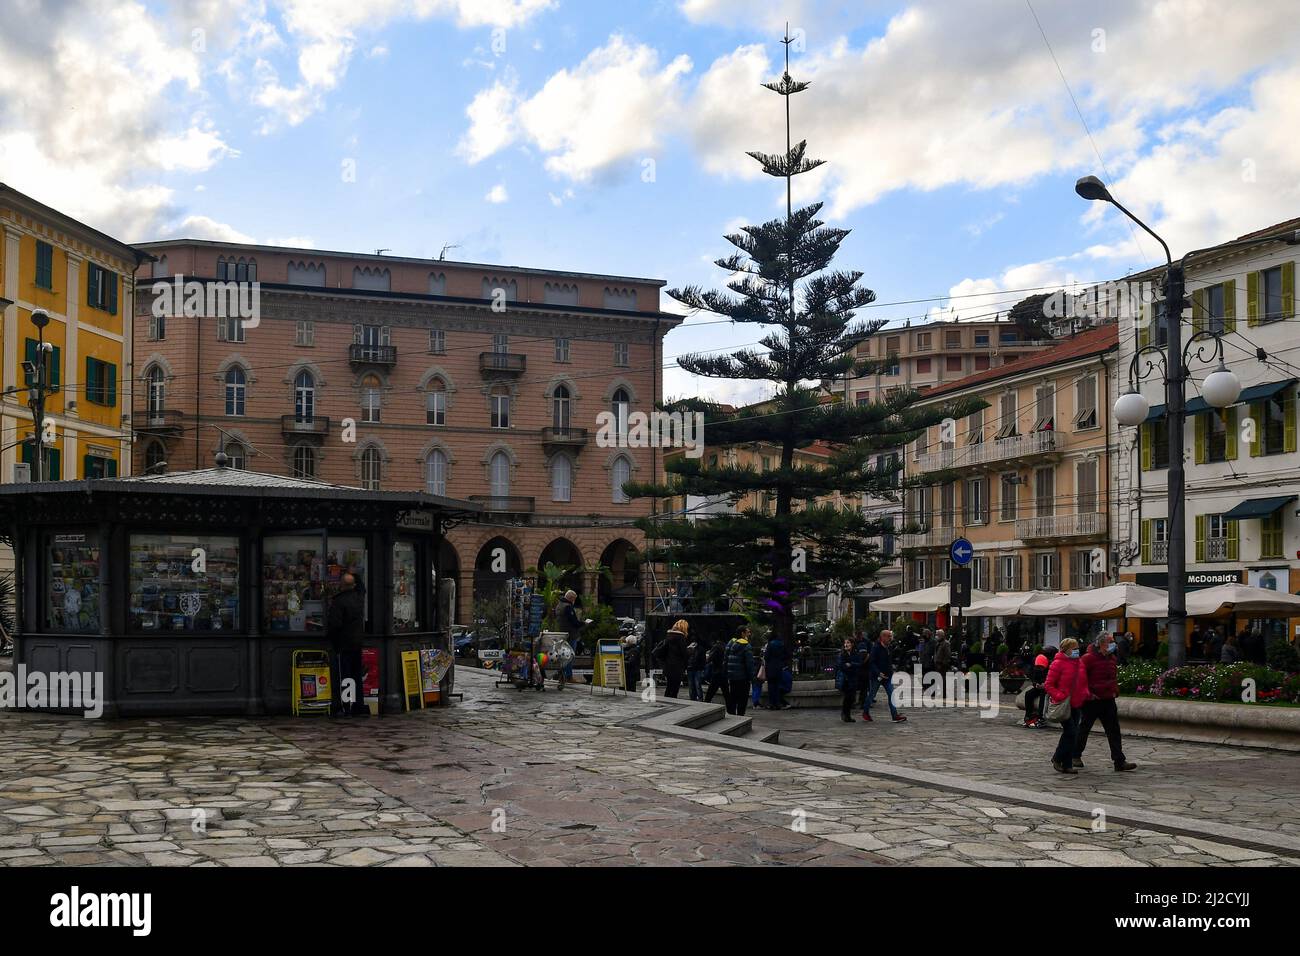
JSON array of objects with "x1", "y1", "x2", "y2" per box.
[{"x1": 0, "y1": 670, "x2": 1296, "y2": 866}]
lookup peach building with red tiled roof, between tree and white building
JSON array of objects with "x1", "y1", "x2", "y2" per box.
[{"x1": 901, "y1": 324, "x2": 1118, "y2": 606}]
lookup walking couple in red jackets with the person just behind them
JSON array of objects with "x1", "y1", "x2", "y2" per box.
[{"x1": 1024, "y1": 633, "x2": 1138, "y2": 774}]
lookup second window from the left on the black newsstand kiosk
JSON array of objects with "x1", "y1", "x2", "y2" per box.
[{"x1": 129, "y1": 535, "x2": 239, "y2": 633}]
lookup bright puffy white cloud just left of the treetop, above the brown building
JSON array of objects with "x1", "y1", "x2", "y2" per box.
[{"x1": 458, "y1": 35, "x2": 692, "y2": 182}]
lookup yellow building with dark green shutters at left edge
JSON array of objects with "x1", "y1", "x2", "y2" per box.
[{"x1": 0, "y1": 183, "x2": 147, "y2": 483}]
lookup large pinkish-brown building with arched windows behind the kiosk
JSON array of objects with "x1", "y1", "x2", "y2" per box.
[{"x1": 134, "y1": 241, "x2": 681, "y2": 622}]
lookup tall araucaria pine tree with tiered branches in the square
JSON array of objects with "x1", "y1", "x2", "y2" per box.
[{"x1": 627, "y1": 36, "x2": 983, "y2": 646}]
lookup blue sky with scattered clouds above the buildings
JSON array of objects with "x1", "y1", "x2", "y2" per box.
[{"x1": 0, "y1": 0, "x2": 1300, "y2": 399}]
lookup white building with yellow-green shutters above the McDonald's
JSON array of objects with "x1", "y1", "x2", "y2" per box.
[{"x1": 1115, "y1": 219, "x2": 1300, "y2": 647}]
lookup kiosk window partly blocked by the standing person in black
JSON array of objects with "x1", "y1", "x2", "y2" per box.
[{"x1": 261, "y1": 533, "x2": 368, "y2": 632}]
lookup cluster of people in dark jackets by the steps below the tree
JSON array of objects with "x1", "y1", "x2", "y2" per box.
[{"x1": 651, "y1": 620, "x2": 792, "y2": 715}]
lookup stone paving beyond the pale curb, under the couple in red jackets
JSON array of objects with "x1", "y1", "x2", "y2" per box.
[{"x1": 754, "y1": 697, "x2": 1300, "y2": 835}]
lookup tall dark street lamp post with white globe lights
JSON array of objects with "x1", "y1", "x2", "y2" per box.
[{"x1": 1074, "y1": 176, "x2": 1300, "y2": 667}]
